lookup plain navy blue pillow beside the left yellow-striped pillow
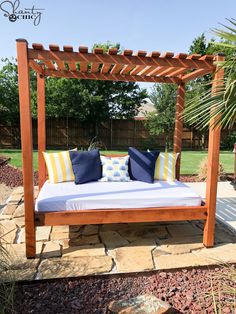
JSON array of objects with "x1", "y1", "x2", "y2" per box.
[{"x1": 70, "y1": 149, "x2": 102, "y2": 184}]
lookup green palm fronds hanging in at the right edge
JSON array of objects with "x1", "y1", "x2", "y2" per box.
[{"x1": 184, "y1": 19, "x2": 236, "y2": 128}]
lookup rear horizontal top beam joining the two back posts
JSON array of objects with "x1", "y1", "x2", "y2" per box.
[{"x1": 45, "y1": 70, "x2": 181, "y2": 84}]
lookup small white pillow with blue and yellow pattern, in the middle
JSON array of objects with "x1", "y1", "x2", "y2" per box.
[{"x1": 100, "y1": 156, "x2": 130, "y2": 182}]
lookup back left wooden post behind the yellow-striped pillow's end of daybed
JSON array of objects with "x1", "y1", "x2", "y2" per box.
[{"x1": 37, "y1": 73, "x2": 46, "y2": 189}]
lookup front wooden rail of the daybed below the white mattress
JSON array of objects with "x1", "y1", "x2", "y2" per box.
[{"x1": 37, "y1": 206, "x2": 207, "y2": 226}]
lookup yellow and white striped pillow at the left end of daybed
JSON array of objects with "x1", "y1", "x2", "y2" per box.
[{"x1": 43, "y1": 149, "x2": 76, "y2": 183}]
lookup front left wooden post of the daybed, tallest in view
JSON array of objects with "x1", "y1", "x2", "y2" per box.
[{"x1": 16, "y1": 39, "x2": 36, "y2": 258}]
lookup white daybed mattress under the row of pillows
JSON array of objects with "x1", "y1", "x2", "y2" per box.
[{"x1": 35, "y1": 181, "x2": 201, "y2": 212}]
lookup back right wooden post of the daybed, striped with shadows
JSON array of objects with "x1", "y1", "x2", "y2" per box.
[{"x1": 174, "y1": 82, "x2": 185, "y2": 180}]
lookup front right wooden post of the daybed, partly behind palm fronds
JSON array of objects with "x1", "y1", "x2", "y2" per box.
[{"x1": 203, "y1": 55, "x2": 224, "y2": 247}]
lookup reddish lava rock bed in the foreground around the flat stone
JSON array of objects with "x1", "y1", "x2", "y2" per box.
[{"x1": 15, "y1": 266, "x2": 236, "y2": 314}]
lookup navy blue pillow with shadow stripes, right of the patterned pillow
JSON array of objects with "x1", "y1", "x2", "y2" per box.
[{"x1": 128, "y1": 147, "x2": 160, "y2": 183}]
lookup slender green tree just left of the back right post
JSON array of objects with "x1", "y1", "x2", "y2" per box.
[{"x1": 146, "y1": 84, "x2": 177, "y2": 149}]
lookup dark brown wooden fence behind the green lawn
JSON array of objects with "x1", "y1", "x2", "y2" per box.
[{"x1": 0, "y1": 118, "x2": 236, "y2": 150}]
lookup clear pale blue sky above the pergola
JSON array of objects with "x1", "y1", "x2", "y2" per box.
[{"x1": 0, "y1": 0, "x2": 236, "y2": 89}]
